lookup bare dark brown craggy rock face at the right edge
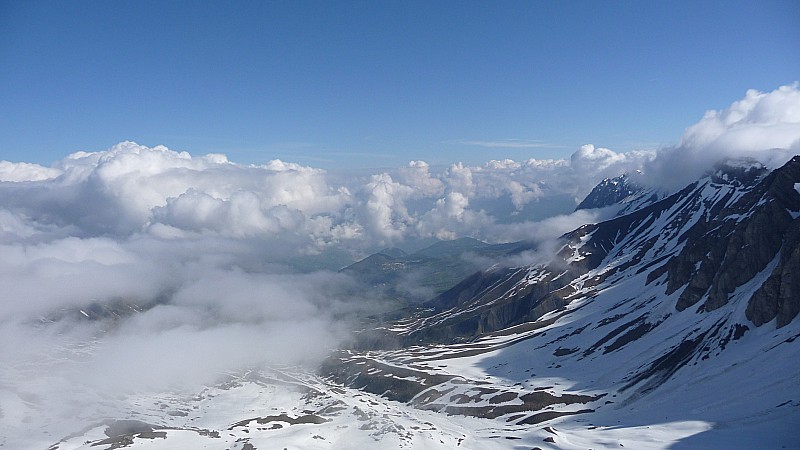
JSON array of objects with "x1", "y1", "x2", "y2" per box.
[{"x1": 648, "y1": 157, "x2": 800, "y2": 326}]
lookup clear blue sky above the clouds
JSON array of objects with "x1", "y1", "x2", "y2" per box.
[{"x1": 0, "y1": 1, "x2": 800, "y2": 168}]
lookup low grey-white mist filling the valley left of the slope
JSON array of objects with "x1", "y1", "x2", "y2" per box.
[{"x1": 0, "y1": 235, "x2": 380, "y2": 443}]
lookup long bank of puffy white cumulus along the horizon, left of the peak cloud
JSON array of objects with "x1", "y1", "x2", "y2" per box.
[{"x1": 0, "y1": 142, "x2": 656, "y2": 254}]
